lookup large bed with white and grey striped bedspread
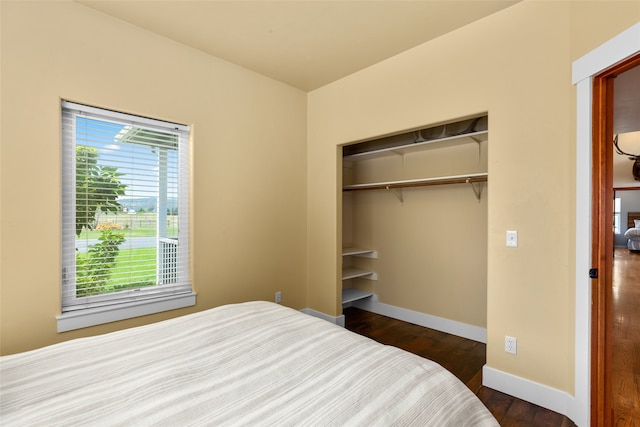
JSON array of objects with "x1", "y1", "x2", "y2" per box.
[{"x1": 0, "y1": 301, "x2": 498, "y2": 426}]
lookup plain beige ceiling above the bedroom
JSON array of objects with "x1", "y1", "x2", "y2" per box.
[{"x1": 76, "y1": 0, "x2": 520, "y2": 91}]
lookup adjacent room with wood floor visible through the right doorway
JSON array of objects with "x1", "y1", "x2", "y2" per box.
[{"x1": 611, "y1": 66, "x2": 640, "y2": 425}]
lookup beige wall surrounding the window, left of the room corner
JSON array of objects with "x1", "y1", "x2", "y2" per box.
[{"x1": 0, "y1": 1, "x2": 306, "y2": 354}]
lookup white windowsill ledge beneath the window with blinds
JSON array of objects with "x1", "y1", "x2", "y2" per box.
[{"x1": 56, "y1": 292, "x2": 196, "y2": 332}]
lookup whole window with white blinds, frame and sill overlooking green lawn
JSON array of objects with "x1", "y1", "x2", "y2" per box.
[{"x1": 58, "y1": 101, "x2": 195, "y2": 331}]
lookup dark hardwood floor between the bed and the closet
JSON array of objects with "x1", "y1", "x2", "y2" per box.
[{"x1": 344, "y1": 307, "x2": 575, "y2": 427}]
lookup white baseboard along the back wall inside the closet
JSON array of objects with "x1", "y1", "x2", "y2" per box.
[{"x1": 352, "y1": 298, "x2": 487, "y2": 344}]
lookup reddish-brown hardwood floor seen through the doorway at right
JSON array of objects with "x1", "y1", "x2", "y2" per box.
[{"x1": 612, "y1": 248, "x2": 640, "y2": 427}]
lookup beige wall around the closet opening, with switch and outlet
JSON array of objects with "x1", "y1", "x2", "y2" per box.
[{"x1": 308, "y1": 1, "x2": 640, "y2": 393}]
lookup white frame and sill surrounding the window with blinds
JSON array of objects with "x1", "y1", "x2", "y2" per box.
[{"x1": 56, "y1": 101, "x2": 196, "y2": 332}]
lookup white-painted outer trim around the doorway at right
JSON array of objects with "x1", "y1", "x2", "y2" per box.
[{"x1": 567, "y1": 22, "x2": 640, "y2": 426}]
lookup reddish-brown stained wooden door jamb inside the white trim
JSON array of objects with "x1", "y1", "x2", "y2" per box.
[{"x1": 591, "y1": 53, "x2": 640, "y2": 426}]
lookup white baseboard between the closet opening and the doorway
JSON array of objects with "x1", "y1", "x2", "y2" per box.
[{"x1": 482, "y1": 365, "x2": 575, "y2": 419}]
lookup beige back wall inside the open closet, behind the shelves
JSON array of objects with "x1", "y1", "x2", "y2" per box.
[{"x1": 343, "y1": 140, "x2": 491, "y2": 328}]
